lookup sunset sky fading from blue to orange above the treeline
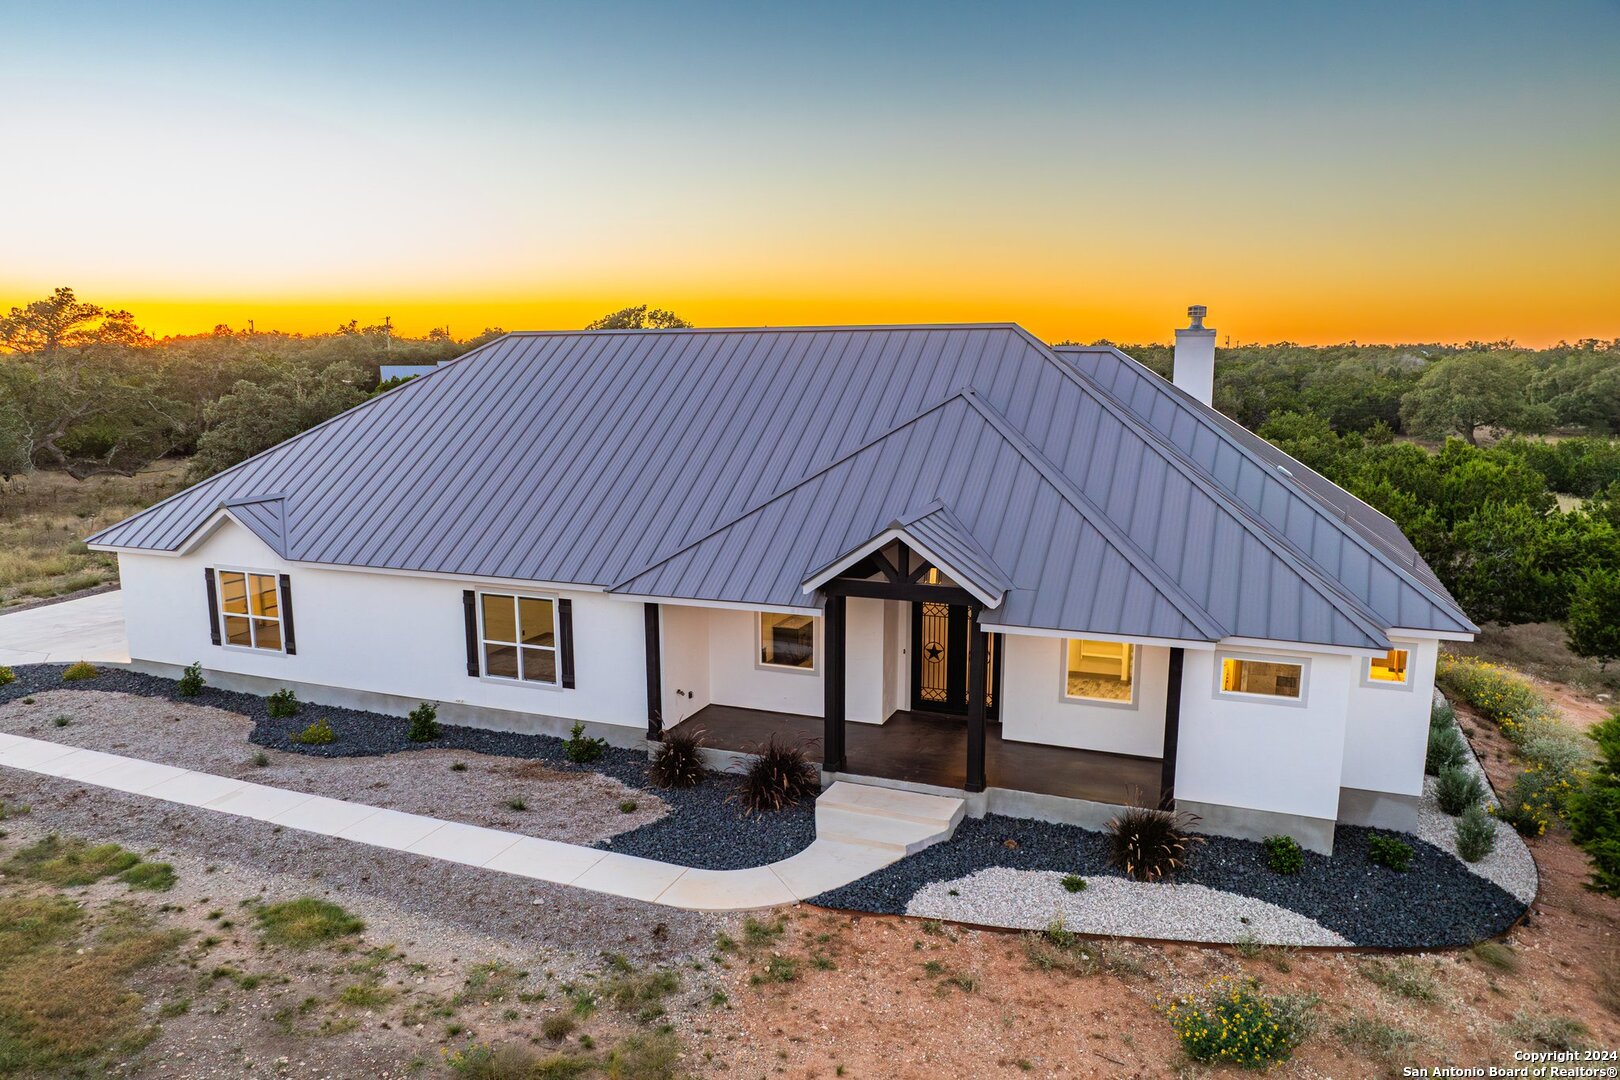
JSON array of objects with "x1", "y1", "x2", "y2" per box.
[{"x1": 0, "y1": 0, "x2": 1620, "y2": 343}]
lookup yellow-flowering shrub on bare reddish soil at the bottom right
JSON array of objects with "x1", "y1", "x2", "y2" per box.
[{"x1": 1165, "y1": 978, "x2": 1309, "y2": 1070}]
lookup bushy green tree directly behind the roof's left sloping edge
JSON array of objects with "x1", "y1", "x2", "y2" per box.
[{"x1": 191, "y1": 361, "x2": 366, "y2": 479}]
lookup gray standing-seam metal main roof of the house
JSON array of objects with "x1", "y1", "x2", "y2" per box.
[{"x1": 91, "y1": 324, "x2": 1471, "y2": 648}]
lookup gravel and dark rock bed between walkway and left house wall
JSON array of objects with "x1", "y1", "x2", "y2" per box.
[{"x1": 0, "y1": 664, "x2": 815, "y2": 870}]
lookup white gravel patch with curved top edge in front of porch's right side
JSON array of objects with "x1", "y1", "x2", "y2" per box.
[{"x1": 906, "y1": 866, "x2": 1351, "y2": 946}]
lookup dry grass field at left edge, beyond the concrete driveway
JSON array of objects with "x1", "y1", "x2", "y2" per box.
[{"x1": 0, "y1": 461, "x2": 186, "y2": 607}]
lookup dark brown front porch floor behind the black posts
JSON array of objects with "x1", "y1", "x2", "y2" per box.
[{"x1": 682, "y1": 704, "x2": 1162, "y2": 805}]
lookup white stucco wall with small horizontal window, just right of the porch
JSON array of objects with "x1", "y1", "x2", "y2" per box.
[{"x1": 1176, "y1": 648, "x2": 1347, "y2": 819}]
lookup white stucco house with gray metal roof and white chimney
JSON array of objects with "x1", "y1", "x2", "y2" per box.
[{"x1": 91, "y1": 308, "x2": 1476, "y2": 852}]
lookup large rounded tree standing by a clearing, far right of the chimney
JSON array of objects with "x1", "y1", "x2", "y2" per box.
[{"x1": 1401, "y1": 353, "x2": 1552, "y2": 445}]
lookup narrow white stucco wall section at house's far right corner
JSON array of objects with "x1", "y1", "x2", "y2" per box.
[{"x1": 1343, "y1": 638, "x2": 1440, "y2": 795}]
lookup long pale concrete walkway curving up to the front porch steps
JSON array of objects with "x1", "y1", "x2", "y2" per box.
[{"x1": 0, "y1": 733, "x2": 962, "y2": 912}]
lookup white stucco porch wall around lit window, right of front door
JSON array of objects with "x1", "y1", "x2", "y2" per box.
[{"x1": 998, "y1": 633, "x2": 1170, "y2": 758}]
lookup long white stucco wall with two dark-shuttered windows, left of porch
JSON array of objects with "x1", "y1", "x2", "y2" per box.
[{"x1": 118, "y1": 521, "x2": 646, "y2": 729}]
